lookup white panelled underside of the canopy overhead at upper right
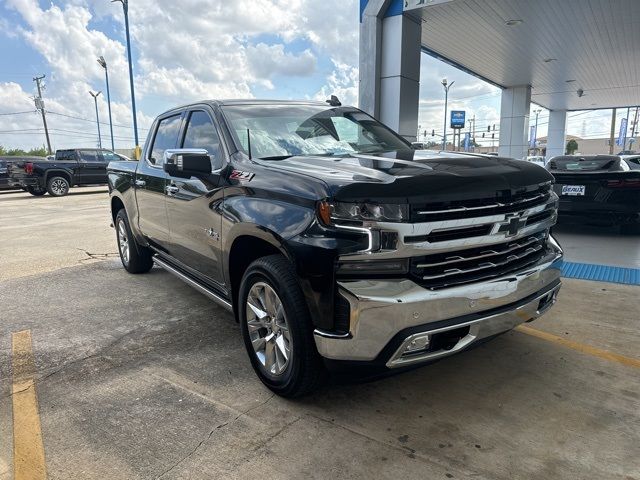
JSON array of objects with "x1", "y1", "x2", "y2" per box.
[{"x1": 404, "y1": 0, "x2": 640, "y2": 110}]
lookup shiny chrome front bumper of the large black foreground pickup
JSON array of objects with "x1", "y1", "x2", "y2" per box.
[{"x1": 314, "y1": 240, "x2": 562, "y2": 368}]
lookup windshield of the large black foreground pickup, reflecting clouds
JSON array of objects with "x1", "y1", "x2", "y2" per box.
[{"x1": 223, "y1": 105, "x2": 411, "y2": 160}]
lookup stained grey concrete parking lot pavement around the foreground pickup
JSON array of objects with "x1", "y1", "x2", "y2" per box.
[{"x1": 0, "y1": 187, "x2": 640, "y2": 480}]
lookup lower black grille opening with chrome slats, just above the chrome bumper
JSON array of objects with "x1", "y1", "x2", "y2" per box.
[{"x1": 410, "y1": 232, "x2": 547, "y2": 289}]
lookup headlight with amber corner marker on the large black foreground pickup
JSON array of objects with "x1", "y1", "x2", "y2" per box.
[{"x1": 318, "y1": 202, "x2": 409, "y2": 225}]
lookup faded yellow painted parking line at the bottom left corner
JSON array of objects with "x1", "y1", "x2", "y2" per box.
[{"x1": 12, "y1": 330, "x2": 47, "y2": 480}]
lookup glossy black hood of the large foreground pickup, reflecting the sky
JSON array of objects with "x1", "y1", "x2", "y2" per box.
[{"x1": 252, "y1": 150, "x2": 553, "y2": 203}]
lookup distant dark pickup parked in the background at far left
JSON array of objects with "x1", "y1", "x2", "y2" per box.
[{"x1": 8, "y1": 148, "x2": 128, "y2": 197}]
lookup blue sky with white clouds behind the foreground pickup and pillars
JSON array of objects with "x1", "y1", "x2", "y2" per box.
[{"x1": 0, "y1": 0, "x2": 620, "y2": 148}]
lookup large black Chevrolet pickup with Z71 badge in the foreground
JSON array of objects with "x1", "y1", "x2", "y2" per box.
[{"x1": 108, "y1": 100, "x2": 562, "y2": 396}]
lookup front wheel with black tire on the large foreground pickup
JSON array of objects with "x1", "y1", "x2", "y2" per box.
[{"x1": 237, "y1": 255, "x2": 325, "y2": 397}]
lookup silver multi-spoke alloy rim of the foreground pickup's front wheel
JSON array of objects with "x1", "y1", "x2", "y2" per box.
[{"x1": 246, "y1": 282, "x2": 293, "y2": 376}]
